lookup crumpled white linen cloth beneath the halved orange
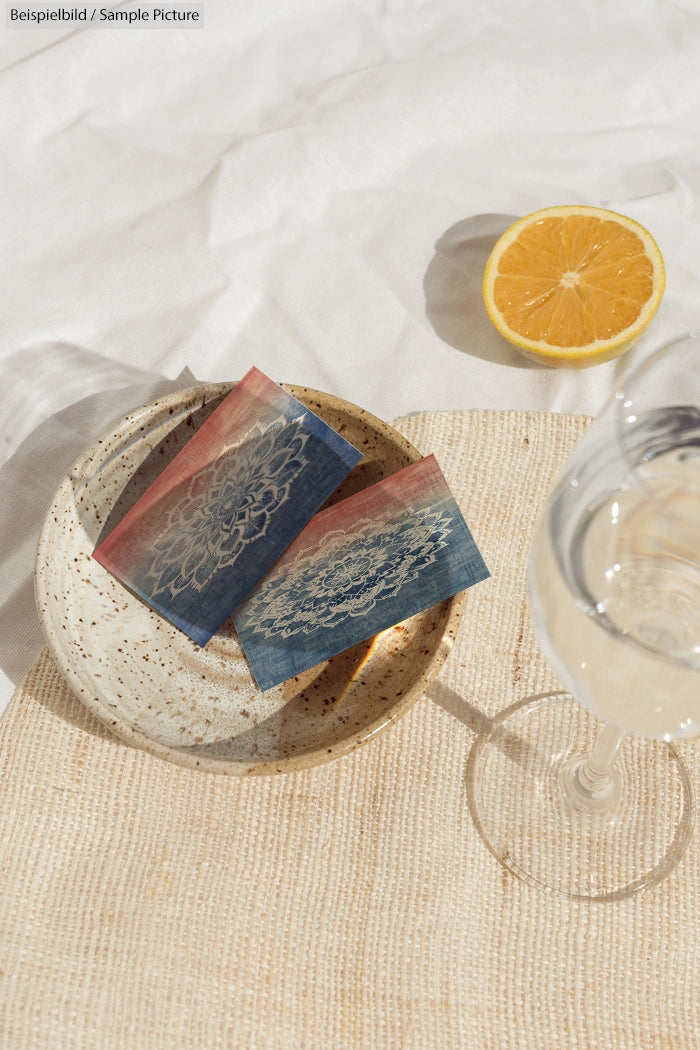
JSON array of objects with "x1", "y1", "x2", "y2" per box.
[{"x1": 0, "y1": 0, "x2": 700, "y2": 709}]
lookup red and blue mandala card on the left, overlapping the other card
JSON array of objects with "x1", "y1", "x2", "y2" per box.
[{"x1": 93, "y1": 369, "x2": 362, "y2": 646}]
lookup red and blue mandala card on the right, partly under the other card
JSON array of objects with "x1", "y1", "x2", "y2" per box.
[{"x1": 233, "y1": 456, "x2": 489, "y2": 690}]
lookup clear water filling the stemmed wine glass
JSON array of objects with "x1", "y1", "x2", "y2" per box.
[{"x1": 530, "y1": 408, "x2": 700, "y2": 740}]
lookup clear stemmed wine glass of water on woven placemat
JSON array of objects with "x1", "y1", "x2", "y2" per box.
[{"x1": 469, "y1": 335, "x2": 700, "y2": 901}]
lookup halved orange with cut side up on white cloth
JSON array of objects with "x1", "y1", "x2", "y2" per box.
[{"x1": 483, "y1": 205, "x2": 665, "y2": 368}]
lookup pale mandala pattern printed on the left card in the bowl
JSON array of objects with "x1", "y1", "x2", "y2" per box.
[{"x1": 145, "y1": 416, "x2": 309, "y2": 597}]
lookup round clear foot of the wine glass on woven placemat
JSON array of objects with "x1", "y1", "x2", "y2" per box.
[{"x1": 468, "y1": 693, "x2": 695, "y2": 901}]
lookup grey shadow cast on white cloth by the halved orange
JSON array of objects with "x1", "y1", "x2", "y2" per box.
[{"x1": 423, "y1": 214, "x2": 538, "y2": 369}]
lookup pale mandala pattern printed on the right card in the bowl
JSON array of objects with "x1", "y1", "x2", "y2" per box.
[{"x1": 246, "y1": 510, "x2": 452, "y2": 638}]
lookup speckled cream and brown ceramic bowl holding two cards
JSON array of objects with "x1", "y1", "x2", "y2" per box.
[{"x1": 36, "y1": 383, "x2": 462, "y2": 775}]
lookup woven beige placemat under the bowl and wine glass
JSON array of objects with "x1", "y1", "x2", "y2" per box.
[{"x1": 0, "y1": 412, "x2": 700, "y2": 1050}]
